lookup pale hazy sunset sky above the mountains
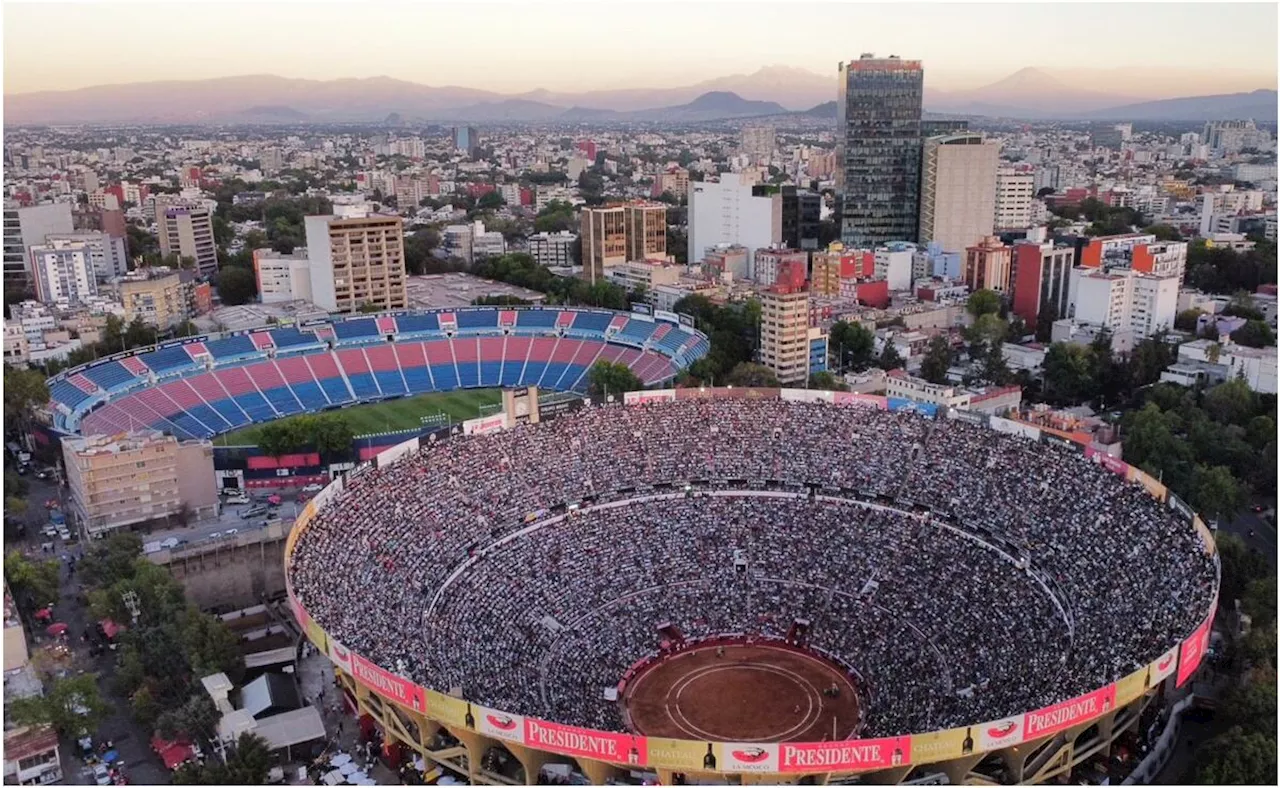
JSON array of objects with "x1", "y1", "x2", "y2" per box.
[{"x1": 4, "y1": 0, "x2": 1276, "y2": 95}]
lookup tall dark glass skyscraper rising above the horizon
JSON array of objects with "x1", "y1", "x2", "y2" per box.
[{"x1": 836, "y1": 55, "x2": 924, "y2": 248}]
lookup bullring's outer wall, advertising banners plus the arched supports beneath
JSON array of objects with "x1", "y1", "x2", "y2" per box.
[{"x1": 285, "y1": 389, "x2": 1217, "y2": 784}]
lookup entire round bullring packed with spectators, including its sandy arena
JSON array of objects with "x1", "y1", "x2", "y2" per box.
[{"x1": 285, "y1": 388, "x2": 1219, "y2": 784}]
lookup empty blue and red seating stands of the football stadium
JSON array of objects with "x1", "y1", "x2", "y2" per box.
[{"x1": 50, "y1": 307, "x2": 710, "y2": 439}]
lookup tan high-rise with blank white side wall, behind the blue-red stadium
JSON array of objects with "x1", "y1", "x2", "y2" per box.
[{"x1": 305, "y1": 212, "x2": 408, "y2": 312}]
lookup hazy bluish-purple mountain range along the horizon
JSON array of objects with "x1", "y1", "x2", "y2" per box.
[{"x1": 4, "y1": 65, "x2": 1276, "y2": 125}]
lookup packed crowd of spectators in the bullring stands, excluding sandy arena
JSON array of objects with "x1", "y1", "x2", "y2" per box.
[{"x1": 289, "y1": 399, "x2": 1216, "y2": 737}]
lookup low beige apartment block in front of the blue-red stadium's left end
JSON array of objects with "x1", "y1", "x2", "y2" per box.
[{"x1": 63, "y1": 430, "x2": 218, "y2": 536}]
